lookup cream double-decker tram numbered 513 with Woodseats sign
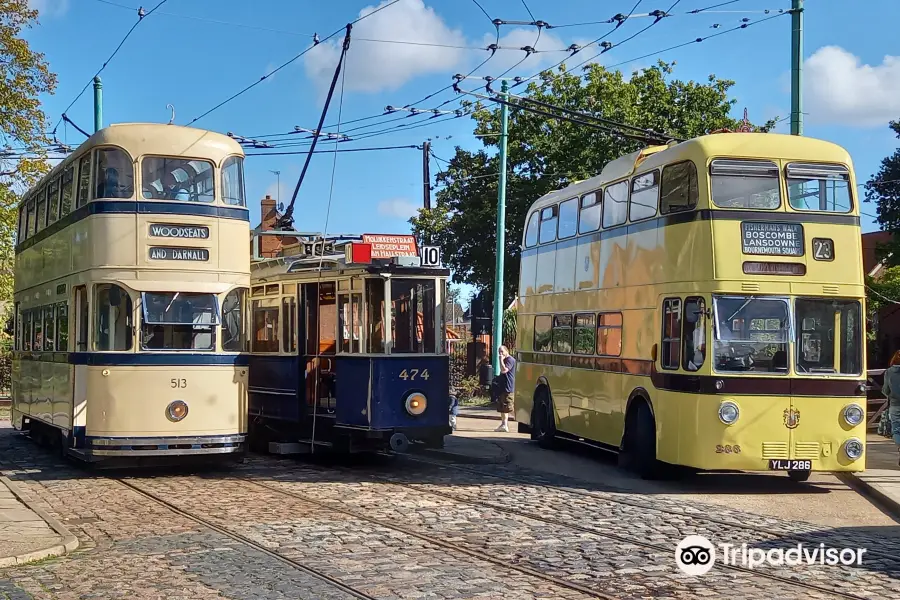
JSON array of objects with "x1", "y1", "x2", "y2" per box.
[{"x1": 12, "y1": 124, "x2": 250, "y2": 462}]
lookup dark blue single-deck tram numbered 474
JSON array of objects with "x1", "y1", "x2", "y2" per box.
[{"x1": 249, "y1": 235, "x2": 451, "y2": 454}]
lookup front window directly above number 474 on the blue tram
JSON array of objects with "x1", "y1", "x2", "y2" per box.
[{"x1": 391, "y1": 279, "x2": 437, "y2": 354}]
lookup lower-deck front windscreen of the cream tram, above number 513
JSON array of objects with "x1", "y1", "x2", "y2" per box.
[{"x1": 141, "y1": 292, "x2": 219, "y2": 351}]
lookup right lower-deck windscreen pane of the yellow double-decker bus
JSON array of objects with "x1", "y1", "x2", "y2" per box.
[{"x1": 795, "y1": 298, "x2": 862, "y2": 375}]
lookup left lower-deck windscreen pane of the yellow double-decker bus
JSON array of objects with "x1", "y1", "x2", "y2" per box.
[{"x1": 713, "y1": 296, "x2": 790, "y2": 373}]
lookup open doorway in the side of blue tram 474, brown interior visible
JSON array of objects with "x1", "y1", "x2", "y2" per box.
[{"x1": 302, "y1": 281, "x2": 337, "y2": 415}]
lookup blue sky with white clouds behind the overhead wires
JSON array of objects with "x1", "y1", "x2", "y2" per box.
[{"x1": 27, "y1": 0, "x2": 900, "y2": 254}]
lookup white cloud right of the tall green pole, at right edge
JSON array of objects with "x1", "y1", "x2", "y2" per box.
[{"x1": 804, "y1": 46, "x2": 900, "y2": 127}]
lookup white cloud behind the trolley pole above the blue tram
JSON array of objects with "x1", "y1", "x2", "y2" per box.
[{"x1": 304, "y1": 0, "x2": 471, "y2": 92}]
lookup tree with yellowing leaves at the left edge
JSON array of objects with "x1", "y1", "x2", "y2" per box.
[{"x1": 0, "y1": 0, "x2": 56, "y2": 301}]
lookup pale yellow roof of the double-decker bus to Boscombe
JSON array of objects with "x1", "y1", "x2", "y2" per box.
[{"x1": 529, "y1": 133, "x2": 852, "y2": 212}]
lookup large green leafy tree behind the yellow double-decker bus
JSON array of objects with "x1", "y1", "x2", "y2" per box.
[{"x1": 410, "y1": 62, "x2": 774, "y2": 305}]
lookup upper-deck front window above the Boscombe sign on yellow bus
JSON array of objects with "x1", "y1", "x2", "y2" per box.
[{"x1": 709, "y1": 158, "x2": 781, "y2": 210}]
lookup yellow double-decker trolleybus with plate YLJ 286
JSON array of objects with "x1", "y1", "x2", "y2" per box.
[{"x1": 515, "y1": 133, "x2": 865, "y2": 481}]
